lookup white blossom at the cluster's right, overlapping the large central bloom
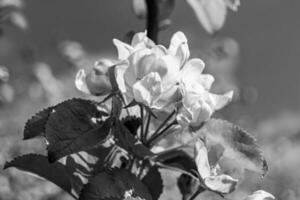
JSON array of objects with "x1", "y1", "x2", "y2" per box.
[{"x1": 177, "y1": 59, "x2": 233, "y2": 127}]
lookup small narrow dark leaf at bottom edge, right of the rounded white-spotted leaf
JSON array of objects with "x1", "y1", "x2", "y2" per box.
[{"x1": 142, "y1": 167, "x2": 163, "y2": 200}]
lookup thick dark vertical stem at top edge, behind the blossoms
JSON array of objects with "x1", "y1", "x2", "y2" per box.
[{"x1": 146, "y1": 0, "x2": 159, "y2": 43}]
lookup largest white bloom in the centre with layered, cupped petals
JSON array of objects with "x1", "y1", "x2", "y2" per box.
[{"x1": 114, "y1": 32, "x2": 190, "y2": 109}]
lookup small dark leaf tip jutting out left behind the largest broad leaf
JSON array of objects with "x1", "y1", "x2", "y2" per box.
[{"x1": 24, "y1": 107, "x2": 53, "y2": 140}]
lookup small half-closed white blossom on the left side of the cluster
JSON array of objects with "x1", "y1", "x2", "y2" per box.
[{"x1": 75, "y1": 60, "x2": 113, "y2": 96}]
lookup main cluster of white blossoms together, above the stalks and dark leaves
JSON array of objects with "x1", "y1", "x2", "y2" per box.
[{"x1": 76, "y1": 32, "x2": 233, "y2": 128}]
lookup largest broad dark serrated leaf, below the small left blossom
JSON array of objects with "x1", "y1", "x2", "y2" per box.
[{"x1": 46, "y1": 99, "x2": 111, "y2": 162}]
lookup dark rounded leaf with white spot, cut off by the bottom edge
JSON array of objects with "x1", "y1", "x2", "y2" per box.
[{"x1": 79, "y1": 169, "x2": 152, "y2": 200}]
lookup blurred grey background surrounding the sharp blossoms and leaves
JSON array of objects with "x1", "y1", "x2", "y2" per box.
[{"x1": 0, "y1": 0, "x2": 300, "y2": 200}]
